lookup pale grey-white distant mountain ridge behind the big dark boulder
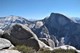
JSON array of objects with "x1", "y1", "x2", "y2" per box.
[{"x1": 0, "y1": 15, "x2": 29, "y2": 29}]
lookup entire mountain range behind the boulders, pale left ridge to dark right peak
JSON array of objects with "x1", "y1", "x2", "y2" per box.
[{"x1": 0, "y1": 13, "x2": 80, "y2": 49}]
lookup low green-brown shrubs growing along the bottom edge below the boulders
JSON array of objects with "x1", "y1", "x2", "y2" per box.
[{"x1": 13, "y1": 45, "x2": 77, "y2": 53}]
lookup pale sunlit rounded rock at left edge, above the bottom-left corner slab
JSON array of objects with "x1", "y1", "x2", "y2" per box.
[{"x1": 0, "y1": 38, "x2": 13, "y2": 49}]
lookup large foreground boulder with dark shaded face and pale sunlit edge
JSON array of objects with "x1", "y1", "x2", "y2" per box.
[{"x1": 2, "y1": 24, "x2": 52, "y2": 50}]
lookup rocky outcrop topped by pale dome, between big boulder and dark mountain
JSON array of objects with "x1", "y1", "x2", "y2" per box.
[{"x1": 31, "y1": 21, "x2": 49, "y2": 38}]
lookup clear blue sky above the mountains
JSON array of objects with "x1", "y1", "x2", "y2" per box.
[{"x1": 0, "y1": 0, "x2": 80, "y2": 19}]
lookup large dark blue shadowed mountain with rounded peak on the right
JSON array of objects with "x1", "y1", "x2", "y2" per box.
[{"x1": 44, "y1": 13, "x2": 80, "y2": 49}]
